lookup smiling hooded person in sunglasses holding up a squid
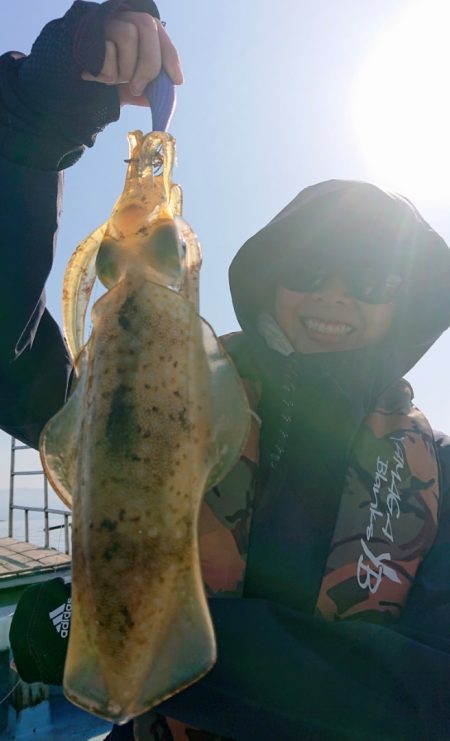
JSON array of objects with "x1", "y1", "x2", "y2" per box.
[{"x1": 0, "y1": 0, "x2": 450, "y2": 741}]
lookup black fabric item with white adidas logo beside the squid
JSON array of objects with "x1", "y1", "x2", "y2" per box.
[{"x1": 9, "y1": 578, "x2": 72, "y2": 684}]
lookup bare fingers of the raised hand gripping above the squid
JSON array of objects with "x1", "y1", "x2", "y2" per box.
[{"x1": 81, "y1": 10, "x2": 183, "y2": 106}]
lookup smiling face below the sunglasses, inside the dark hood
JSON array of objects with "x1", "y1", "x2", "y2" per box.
[{"x1": 275, "y1": 272, "x2": 394, "y2": 353}]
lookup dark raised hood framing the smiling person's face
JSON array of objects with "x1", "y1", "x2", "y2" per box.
[{"x1": 230, "y1": 180, "x2": 450, "y2": 382}]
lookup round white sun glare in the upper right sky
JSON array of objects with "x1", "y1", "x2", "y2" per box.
[{"x1": 353, "y1": 0, "x2": 450, "y2": 198}]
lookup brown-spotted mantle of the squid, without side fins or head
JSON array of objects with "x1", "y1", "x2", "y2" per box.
[{"x1": 65, "y1": 274, "x2": 215, "y2": 721}]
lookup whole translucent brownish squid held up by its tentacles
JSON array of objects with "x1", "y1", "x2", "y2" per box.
[{"x1": 41, "y1": 132, "x2": 249, "y2": 723}]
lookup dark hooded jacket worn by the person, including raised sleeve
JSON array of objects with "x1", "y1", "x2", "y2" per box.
[{"x1": 0, "y1": 3, "x2": 450, "y2": 741}]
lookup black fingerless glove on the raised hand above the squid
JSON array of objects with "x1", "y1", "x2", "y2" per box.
[{"x1": 0, "y1": 0, "x2": 159, "y2": 170}]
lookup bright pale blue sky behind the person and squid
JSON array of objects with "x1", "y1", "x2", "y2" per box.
[{"x1": 0, "y1": 0, "x2": 450, "y2": 498}]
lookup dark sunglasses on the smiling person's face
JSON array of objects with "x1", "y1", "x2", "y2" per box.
[{"x1": 280, "y1": 262, "x2": 403, "y2": 304}]
